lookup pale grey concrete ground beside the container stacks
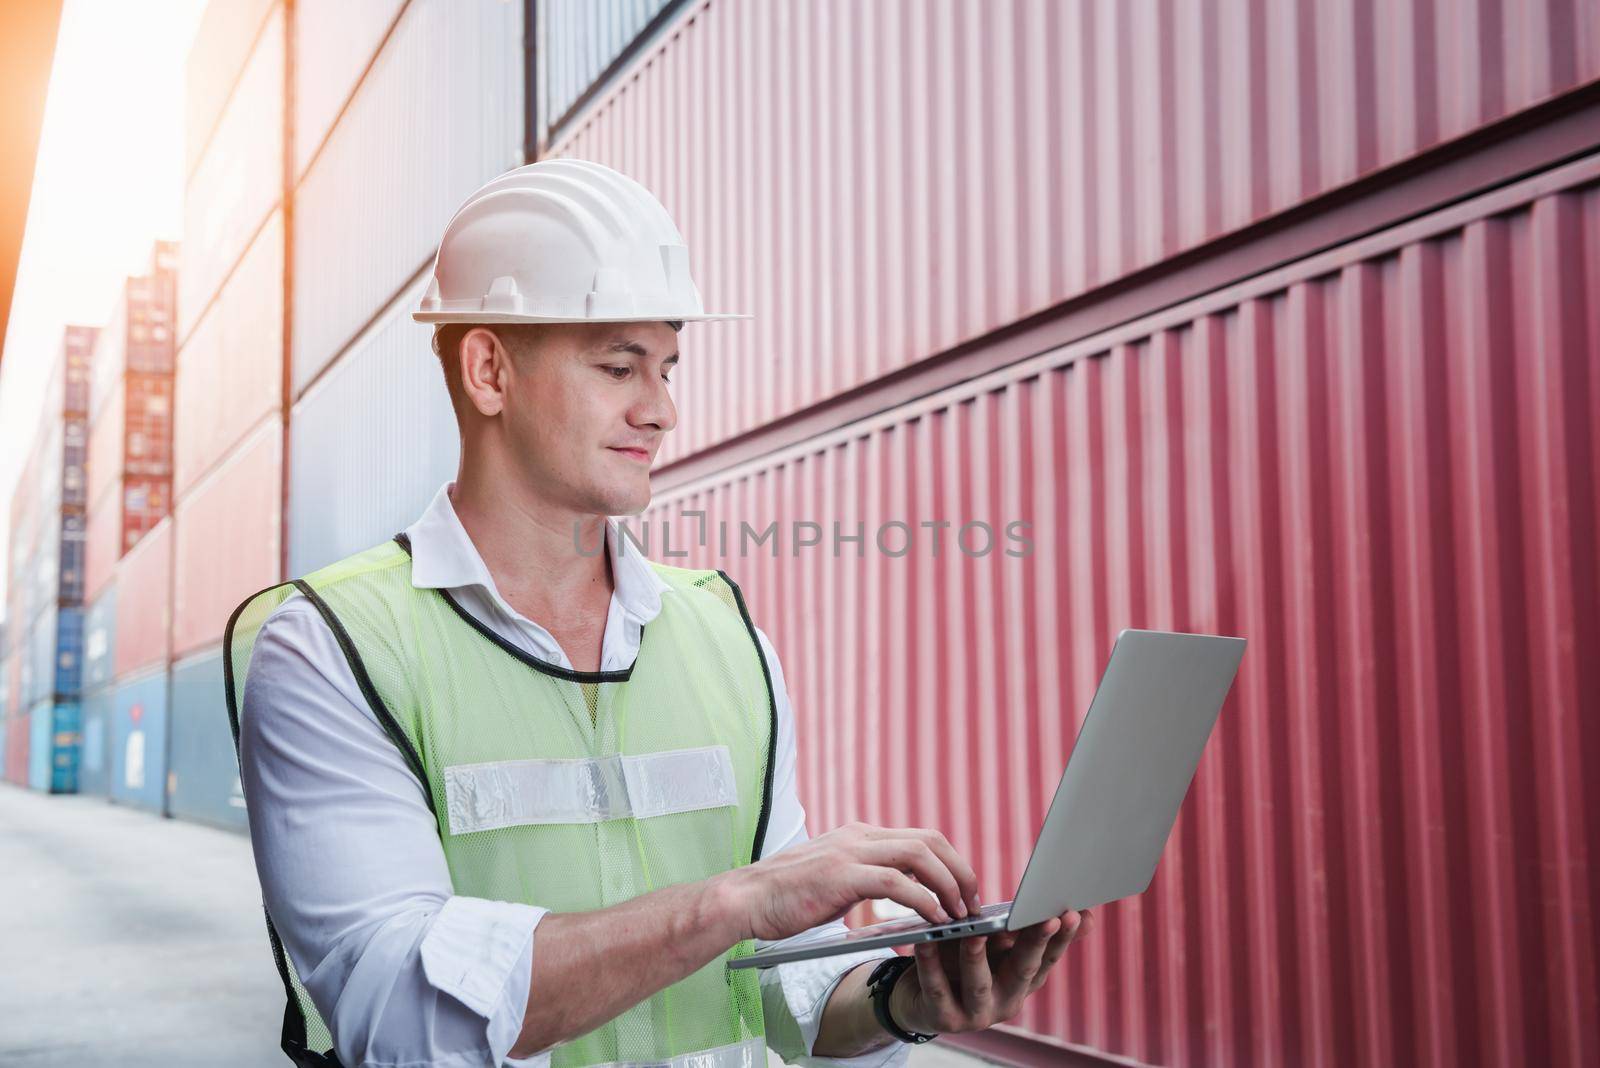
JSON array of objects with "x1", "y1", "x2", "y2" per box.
[{"x1": 0, "y1": 783, "x2": 982, "y2": 1068}]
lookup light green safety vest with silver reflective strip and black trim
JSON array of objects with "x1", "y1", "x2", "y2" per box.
[{"x1": 224, "y1": 534, "x2": 776, "y2": 1068}]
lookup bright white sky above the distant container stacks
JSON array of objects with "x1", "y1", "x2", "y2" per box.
[{"x1": 0, "y1": 0, "x2": 205, "y2": 614}]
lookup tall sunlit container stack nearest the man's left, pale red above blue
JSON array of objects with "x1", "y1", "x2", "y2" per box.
[{"x1": 167, "y1": 0, "x2": 286, "y2": 827}]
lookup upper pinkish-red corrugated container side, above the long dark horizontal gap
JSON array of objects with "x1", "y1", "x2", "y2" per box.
[{"x1": 552, "y1": 0, "x2": 1600, "y2": 462}]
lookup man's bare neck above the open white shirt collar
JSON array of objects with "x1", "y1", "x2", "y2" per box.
[{"x1": 450, "y1": 472, "x2": 614, "y2": 632}]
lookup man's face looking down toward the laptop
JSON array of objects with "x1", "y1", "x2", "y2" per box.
[{"x1": 470, "y1": 323, "x2": 678, "y2": 515}]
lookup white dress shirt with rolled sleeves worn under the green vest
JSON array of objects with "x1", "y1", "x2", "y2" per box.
[{"x1": 240, "y1": 483, "x2": 909, "y2": 1068}]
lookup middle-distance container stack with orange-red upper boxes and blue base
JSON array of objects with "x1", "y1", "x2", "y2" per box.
[{"x1": 80, "y1": 241, "x2": 178, "y2": 812}]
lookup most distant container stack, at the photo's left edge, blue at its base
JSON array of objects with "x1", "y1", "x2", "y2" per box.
[{"x1": 5, "y1": 326, "x2": 96, "y2": 793}]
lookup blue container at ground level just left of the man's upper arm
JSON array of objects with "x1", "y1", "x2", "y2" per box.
[{"x1": 166, "y1": 652, "x2": 246, "y2": 830}]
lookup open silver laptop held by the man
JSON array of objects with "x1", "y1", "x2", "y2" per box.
[{"x1": 728, "y1": 630, "x2": 1245, "y2": 967}]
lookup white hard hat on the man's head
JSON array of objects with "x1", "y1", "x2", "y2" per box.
[{"x1": 411, "y1": 160, "x2": 750, "y2": 323}]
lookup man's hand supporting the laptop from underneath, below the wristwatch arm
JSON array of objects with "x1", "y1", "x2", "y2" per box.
[{"x1": 890, "y1": 908, "x2": 1094, "y2": 1034}]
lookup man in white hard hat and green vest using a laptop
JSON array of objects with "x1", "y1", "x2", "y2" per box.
[{"x1": 227, "y1": 160, "x2": 1088, "y2": 1068}]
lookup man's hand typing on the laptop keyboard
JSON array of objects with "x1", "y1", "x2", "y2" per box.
[{"x1": 715, "y1": 823, "x2": 978, "y2": 940}]
